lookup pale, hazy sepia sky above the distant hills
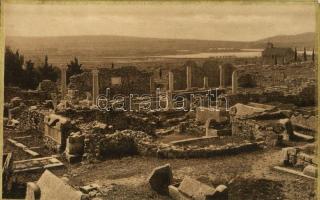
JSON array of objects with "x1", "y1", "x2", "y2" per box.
[{"x1": 5, "y1": 2, "x2": 315, "y2": 41}]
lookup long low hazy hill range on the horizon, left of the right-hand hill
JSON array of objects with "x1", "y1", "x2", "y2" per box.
[{"x1": 6, "y1": 35, "x2": 247, "y2": 56}]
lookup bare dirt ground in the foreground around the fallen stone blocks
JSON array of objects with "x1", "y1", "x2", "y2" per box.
[{"x1": 69, "y1": 149, "x2": 314, "y2": 200}]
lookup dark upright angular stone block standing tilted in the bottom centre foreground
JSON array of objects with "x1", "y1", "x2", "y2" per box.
[{"x1": 148, "y1": 164, "x2": 173, "y2": 194}]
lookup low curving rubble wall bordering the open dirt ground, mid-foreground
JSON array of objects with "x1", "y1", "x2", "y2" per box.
[{"x1": 83, "y1": 130, "x2": 264, "y2": 161}]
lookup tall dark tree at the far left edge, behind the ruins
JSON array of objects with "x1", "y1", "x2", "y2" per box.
[{"x1": 4, "y1": 47, "x2": 24, "y2": 86}]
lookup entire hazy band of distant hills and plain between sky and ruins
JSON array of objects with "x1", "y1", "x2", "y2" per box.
[{"x1": 5, "y1": 33, "x2": 315, "y2": 66}]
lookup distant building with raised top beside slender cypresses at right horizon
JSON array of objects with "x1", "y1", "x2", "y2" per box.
[{"x1": 262, "y1": 42, "x2": 294, "y2": 65}]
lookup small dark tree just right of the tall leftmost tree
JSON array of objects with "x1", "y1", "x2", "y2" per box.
[{"x1": 21, "y1": 60, "x2": 39, "y2": 89}]
